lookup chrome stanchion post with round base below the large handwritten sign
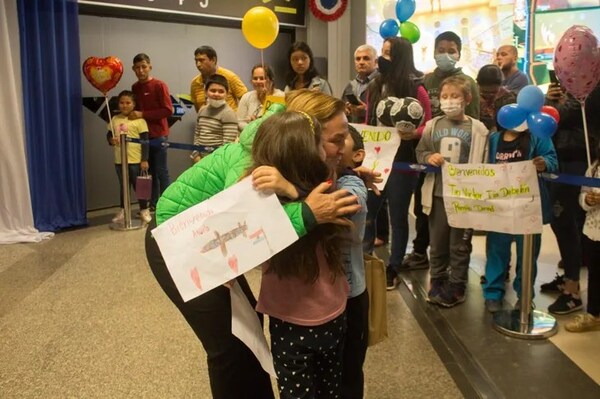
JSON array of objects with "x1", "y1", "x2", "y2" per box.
[{"x1": 493, "y1": 234, "x2": 557, "y2": 339}]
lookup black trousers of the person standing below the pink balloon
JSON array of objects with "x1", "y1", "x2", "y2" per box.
[{"x1": 550, "y1": 162, "x2": 587, "y2": 281}]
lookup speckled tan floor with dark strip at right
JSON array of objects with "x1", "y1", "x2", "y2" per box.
[{"x1": 0, "y1": 212, "x2": 600, "y2": 399}]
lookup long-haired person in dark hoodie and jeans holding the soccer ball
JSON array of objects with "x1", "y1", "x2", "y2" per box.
[{"x1": 363, "y1": 37, "x2": 431, "y2": 289}]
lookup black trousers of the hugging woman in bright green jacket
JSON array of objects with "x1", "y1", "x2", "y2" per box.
[{"x1": 146, "y1": 220, "x2": 274, "y2": 399}]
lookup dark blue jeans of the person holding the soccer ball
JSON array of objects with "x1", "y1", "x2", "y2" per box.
[{"x1": 363, "y1": 172, "x2": 419, "y2": 268}]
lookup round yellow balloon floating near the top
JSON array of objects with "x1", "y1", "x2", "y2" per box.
[{"x1": 242, "y1": 7, "x2": 279, "y2": 49}]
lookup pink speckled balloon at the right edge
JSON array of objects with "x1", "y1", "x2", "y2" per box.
[{"x1": 554, "y1": 25, "x2": 600, "y2": 100}]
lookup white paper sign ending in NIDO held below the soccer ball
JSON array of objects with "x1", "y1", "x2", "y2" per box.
[{"x1": 351, "y1": 123, "x2": 400, "y2": 190}]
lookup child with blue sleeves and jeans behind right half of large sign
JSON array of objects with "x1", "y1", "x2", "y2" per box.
[{"x1": 483, "y1": 123, "x2": 558, "y2": 313}]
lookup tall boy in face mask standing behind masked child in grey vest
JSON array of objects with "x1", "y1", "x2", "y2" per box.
[{"x1": 423, "y1": 31, "x2": 479, "y2": 119}]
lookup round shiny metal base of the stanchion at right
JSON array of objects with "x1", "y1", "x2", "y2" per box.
[{"x1": 493, "y1": 310, "x2": 558, "y2": 339}]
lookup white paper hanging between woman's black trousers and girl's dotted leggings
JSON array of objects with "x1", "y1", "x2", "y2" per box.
[{"x1": 231, "y1": 282, "x2": 277, "y2": 378}]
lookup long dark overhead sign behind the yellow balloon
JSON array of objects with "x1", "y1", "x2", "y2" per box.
[{"x1": 78, "y1": 0, "x2": 306, "y2": 26}]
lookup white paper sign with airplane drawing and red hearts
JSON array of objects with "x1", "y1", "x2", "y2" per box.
[{"x1": 152, "y1": 177, "x2": 298, "y2": 301}]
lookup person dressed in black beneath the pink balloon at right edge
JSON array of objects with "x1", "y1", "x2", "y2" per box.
[{"x1": 541, "y1": 83, "x2": 600, "y2": 314}]
